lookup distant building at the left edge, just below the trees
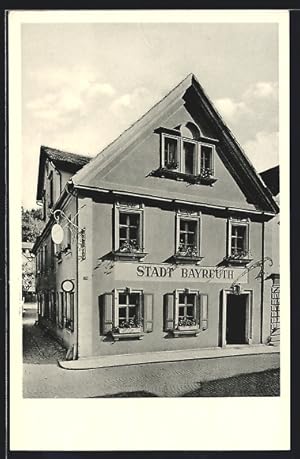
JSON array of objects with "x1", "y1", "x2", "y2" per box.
[{"x1": 22, "y1": 242, "x2": 36, "y2": 302}]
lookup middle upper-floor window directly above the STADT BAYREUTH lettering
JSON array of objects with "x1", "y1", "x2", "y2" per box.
[{"x1": 175, "y1": 210, "x2": 202, "y2": 263}]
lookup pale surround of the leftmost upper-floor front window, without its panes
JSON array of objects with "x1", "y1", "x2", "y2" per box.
[{"x1": 113, "y1": 202, "x2": 145, "y2": 252}]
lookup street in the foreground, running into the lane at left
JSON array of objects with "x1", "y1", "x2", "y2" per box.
[{"x1": 23, "y1": 309, "x2": 279, "y2": 398}]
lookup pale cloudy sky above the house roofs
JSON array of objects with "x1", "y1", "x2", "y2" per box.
[{"x1": 21, "y1": 23, "x2": 279, "y2": 208}]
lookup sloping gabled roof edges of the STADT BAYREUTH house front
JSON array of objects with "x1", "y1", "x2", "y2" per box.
[{"x1": 72, "y1": 74, "x2": 279, "y2": 213}]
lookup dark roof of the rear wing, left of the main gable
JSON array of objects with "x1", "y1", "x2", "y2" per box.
[{"x1": 37, "y1": 145, "x2": 91, "y2": 200}]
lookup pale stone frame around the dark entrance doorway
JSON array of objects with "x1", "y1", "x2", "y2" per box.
[{"x1": 220, "y1": 289, "x2": 253, "y2": 347}]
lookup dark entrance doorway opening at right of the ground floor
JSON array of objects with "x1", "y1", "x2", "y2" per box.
[{"x1": 226, "y1": 294, "x2": 247, "y2": 344}]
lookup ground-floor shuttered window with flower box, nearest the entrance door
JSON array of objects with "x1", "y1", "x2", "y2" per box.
[{"x1": 164, "y1": 289, "x2": 208, "y2": 336}]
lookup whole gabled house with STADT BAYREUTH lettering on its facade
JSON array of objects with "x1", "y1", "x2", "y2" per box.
[{"x1": 34, "y1": 75, "x2": 278, "y2": 358}]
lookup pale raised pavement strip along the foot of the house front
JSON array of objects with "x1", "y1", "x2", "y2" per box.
[{"x1": 58, "y1": 344, "x2": 279, "y2": 370}]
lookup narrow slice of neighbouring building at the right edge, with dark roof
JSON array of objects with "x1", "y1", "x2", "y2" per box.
[{"x1": 260, "y1": 166, "x2": 280, "y2": 345}]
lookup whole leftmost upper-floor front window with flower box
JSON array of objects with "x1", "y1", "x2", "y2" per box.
[{"x1": 114, "y1": 203, "x2": 146, "y2": 259}]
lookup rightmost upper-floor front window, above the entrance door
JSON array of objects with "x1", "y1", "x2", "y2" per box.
[{"x1": 227, "y1": 218, "x2": 251, "y2": 264}]
